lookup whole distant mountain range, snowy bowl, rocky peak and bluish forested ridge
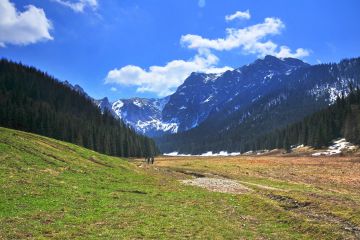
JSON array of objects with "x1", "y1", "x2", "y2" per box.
[{"x1": 88, "y1": 56, "x2": 360, "y2": 153}]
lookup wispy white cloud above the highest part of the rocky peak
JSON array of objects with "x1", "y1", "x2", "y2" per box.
[{"x1": 181, "y1": 18, "x2": 309, "y2": 58}]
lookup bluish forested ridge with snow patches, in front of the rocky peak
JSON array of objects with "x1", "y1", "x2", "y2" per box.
[{"x1": 157, "y1": 58, "x2": 360, "y2": 153}]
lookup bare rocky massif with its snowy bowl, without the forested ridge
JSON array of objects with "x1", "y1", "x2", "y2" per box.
[{"x1": 100, "y1": 56, "x2": 310, "y2": 136}]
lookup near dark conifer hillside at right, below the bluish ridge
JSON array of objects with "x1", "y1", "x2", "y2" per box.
[{"x1": 250, "y1": 89, "x2": 360, "y2": 150}]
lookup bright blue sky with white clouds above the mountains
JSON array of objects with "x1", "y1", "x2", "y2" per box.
[{"x1": 0, "y1": 0, "x2": 360, "y2": 101}]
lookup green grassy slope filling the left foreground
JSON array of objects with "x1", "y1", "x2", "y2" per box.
[{"x1": 0, "y1": 128, "x2": 351, "y2": 239}]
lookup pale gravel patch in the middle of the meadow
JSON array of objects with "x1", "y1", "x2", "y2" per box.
[{"x1": 181, "y1": 177, "x2": 251, "y2": 194}]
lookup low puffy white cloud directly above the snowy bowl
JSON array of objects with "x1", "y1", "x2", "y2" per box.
[{"x1": 105, "y1": 50, "x2": 231, "y2": 96}]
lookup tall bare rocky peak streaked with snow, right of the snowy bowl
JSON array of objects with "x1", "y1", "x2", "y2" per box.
[{"x1": 163, "y1": 56, "x2": 309, "y2": 131}]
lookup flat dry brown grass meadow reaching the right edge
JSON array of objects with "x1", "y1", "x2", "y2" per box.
[{"x1": 155, "y1": 155, "x2": 360, "y2": 193}]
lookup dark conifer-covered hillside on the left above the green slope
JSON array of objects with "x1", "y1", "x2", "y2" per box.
[{"x1": 0, "y1": 59, "x2": 158, "y2": 157}]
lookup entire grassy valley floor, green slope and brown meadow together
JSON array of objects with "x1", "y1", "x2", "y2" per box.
[{"x1": 0, "y1": 128, "x2": 360, "y2": 239}]
